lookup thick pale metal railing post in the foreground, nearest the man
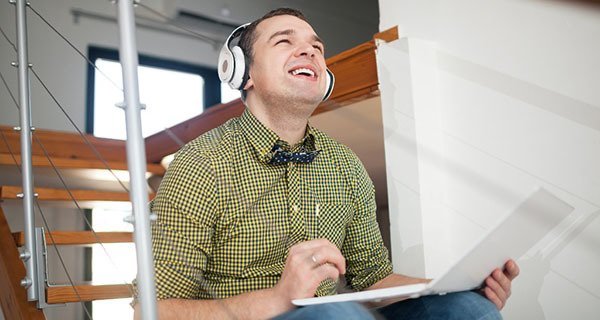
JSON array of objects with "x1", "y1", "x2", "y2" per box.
[{"x1": 119, "y1": 0, "x2": 157, "y2": 320}]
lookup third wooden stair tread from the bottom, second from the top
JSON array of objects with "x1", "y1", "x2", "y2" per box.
[{"x1": 0, "y1": 186, "x2": 154, "y2": 202}]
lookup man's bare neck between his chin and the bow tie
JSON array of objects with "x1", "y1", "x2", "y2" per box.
[{"x1": 246, "y1": 96, "x2": 317, "y2": 145}]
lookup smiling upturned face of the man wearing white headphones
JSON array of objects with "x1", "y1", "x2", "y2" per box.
[{"x1": 246, "y1": 15, "x2": 327, "y2": 106}]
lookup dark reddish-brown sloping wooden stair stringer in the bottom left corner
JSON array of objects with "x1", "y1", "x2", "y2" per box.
[{"x1": 0, "y1": 208, "x2": 45, "y2": 320}]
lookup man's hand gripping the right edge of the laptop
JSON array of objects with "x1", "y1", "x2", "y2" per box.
[{"x1": 482, "y1": 260, "x2": 519, "y2": 310}]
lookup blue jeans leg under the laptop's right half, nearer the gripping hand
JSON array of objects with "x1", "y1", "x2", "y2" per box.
[{"x1": 374, "y1": 291, "x2": 502, "y2": 320}]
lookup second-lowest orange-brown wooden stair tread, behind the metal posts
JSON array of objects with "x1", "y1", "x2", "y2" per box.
[{"x1": 12, "y1": 231, "x2": 133, "y2": 247}]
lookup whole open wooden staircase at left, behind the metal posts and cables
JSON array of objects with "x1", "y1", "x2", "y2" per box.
[{"x1": 0, "y1": 126, "x2": 165, "y2": 319}]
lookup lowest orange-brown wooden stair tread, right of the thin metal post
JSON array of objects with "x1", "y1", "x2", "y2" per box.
[{"x1": 46, "y1": 284, "x2": 133, "y2": 304}]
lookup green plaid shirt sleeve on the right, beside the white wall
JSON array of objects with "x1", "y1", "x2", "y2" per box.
[{"x1": 342, "y1": 154, "x2": 392, "y2": 291}]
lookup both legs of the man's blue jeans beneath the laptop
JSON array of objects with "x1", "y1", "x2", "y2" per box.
[{"x1": 275, "y1": 291, "x2": 502, "y2": 320}]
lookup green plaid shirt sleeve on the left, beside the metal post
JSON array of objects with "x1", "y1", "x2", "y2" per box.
[{"x1": 150, "y1": 146, "x2": 218, "y2": 299}]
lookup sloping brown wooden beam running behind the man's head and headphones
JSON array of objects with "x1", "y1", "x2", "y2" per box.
[{"x1": 145, "y1": 27, "x2": 398, "y2": 162}]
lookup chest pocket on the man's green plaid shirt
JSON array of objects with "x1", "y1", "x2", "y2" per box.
[{"x1": 315, "y1": 202, "x2": 354, "y2": 248}]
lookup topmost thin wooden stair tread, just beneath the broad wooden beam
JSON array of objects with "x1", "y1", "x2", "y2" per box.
[{"x1": 0, "y1": 153, "x2": 166, "y2": 176}]
